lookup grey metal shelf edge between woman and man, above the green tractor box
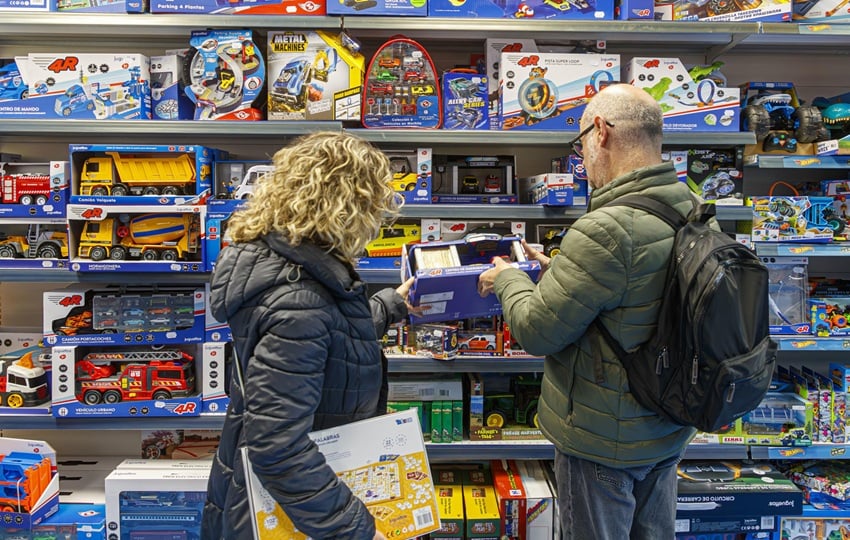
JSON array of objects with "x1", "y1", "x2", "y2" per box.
[{"x1": 389, "y1": 356, "x2": 543, "y2": 373}]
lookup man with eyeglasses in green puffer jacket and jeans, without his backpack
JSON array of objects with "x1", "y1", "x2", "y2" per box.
[{"x1": 478, "y1": 84, "x2": 695, "y2": 540}]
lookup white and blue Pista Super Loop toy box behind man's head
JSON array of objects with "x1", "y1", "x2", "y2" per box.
[{"x1": 499, "y1": 52, "x2": 620, "y2": 130}]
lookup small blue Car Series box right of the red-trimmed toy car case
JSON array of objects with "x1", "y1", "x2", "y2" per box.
[{"x1": 443, "y1": 70, "x2": 490, "y2": 130}]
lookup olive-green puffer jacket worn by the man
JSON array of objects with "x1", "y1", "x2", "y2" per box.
[{"x1": 495, "y1": 163, "x2": 695, "y2": 468}]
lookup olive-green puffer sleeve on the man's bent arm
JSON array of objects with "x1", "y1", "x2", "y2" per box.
[{"x1": 494, "y1": 211, "x2": 632, "y2": 356}]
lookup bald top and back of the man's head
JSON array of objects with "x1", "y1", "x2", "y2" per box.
[{"x1": 582, "y1": 84, "x2": 663, "y2": 153}]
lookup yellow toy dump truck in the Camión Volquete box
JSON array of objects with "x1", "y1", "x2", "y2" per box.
[{"x1": 80, "y1": 152, "x2": 196, "y2": 197}]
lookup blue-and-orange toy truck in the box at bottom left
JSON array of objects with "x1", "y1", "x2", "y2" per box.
[{"x1": 0, "y1": 452, "x2": 53, "y2": 512}]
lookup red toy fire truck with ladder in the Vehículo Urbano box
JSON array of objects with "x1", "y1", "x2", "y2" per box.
[{"x1": 76, "y1": 350, "x2": 195, "y2": 405}]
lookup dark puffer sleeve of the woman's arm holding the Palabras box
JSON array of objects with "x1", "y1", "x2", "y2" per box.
[{"x1": 238, "y1": 291, "x2": 375, "y2": 540}]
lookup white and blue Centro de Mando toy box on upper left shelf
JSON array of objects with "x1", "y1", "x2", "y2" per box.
[{"x1": 0, "y1": 53, "x2": 151, "y2": 120}]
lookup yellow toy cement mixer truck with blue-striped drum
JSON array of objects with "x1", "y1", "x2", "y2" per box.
[{"x1": 78, "y1": 214, "x2": 201, "y2": 261}]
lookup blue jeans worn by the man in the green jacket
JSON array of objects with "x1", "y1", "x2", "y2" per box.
[{"x1": 555, "y1": 452, "x2": 681, "y2": 540}]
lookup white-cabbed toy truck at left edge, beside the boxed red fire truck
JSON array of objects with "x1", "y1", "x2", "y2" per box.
[{"x1": 0, "y1": 351, "x2": 50, "y2": 409}]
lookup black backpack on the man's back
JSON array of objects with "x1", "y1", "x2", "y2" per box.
[{"x1": 592, "y1": 195, "x2": 776, "y2": 432}]
